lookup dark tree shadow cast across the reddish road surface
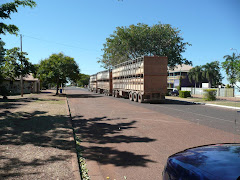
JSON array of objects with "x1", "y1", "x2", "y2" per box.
[{"x1": 73, "y1": 116, "x2": 156, "y2": 167}]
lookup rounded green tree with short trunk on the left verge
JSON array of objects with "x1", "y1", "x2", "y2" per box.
[{"x1": 37, "y1": 53, "x2": 79, "y2": 95}]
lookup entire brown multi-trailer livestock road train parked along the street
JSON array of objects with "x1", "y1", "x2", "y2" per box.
[{"x1": 89, "y1": 56, "x2": 168, "y2": 103}]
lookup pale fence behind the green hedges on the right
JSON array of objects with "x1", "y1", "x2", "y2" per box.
[{"x1": 181, "y1": 87, "x2": 234, "y2": 97}]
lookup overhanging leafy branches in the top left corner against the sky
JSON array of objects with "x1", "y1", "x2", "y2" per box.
[{"x1": 0, "y1": 0, "x2": 36, "y2": 35}]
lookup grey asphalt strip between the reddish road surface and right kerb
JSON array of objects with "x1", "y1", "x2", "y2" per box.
[{"x1": 71, "y1": 88, "x2": 240, "y2": 134}]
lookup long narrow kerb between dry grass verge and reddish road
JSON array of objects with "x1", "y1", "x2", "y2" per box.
[{"x1": 66, "y1": 96, "x2": 82, "y2": 180}]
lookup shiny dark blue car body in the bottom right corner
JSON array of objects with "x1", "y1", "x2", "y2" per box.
[{"x1": 163, "y1": 144, "x2": 240, "y2": 180}]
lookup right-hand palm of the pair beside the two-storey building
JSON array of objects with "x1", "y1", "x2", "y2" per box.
[{"x1": 202, "y1": 61, "x2": 223, "y2": 87}]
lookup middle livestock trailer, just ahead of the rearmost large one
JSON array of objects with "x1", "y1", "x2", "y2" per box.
[{"x1": 97, "y1": 69, "x2": 112, "y2": 96}]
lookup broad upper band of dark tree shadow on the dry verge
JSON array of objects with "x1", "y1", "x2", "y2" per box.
[{"x1": 0, "y1": 111, "x2": 71, "y2": 150}]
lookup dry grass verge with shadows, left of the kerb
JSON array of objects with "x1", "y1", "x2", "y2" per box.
[{"x1": 0, "y1": 90, "x2": 80, "y2": 180}]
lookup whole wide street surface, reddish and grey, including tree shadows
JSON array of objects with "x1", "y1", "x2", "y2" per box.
[{"x1": 67, "y1": 88, "x2": 240, "y2": 180}]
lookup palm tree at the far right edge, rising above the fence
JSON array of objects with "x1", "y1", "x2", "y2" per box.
[{"x1": 222, "y1": 53, "x2": 240, "y2": 86}]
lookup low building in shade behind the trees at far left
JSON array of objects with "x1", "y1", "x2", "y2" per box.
[{"x1": 1, "y1": 74, "x2": 40, "y2": 94}]
